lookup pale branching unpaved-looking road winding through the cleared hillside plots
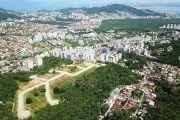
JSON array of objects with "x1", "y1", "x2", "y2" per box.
[{"x1": 17, "y1": 64, "x2": 96, "y2": 119}]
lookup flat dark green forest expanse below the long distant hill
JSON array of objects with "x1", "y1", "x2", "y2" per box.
[{"x1": 95, "y1": 19, "x2": 180, "y2": 33}]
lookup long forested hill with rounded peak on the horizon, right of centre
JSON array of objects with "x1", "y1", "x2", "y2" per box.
[{"x1": 58, "y1": 4, "x2": 161, "y2": 16}]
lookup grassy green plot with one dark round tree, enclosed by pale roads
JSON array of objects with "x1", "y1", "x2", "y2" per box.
[{"x1": 24, "y1": 85, "x2": 47, "y2": 115}]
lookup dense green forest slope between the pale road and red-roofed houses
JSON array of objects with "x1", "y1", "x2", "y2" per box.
[{"x1": 28, "y1": 64, "x2": 142, "y2": 120}]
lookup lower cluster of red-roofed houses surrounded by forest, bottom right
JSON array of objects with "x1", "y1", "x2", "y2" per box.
[{"x1": 103, "y1": 80, "x2": 156, "y2": 118}]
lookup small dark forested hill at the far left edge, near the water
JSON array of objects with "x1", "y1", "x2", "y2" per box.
[{"x1": 0, "y1": 8, "x2": 21, "y2": 20}]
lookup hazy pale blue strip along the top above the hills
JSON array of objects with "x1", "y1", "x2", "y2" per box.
[{"x1": 0, "y1": 0, "x2": 180, "y2": 13}]
